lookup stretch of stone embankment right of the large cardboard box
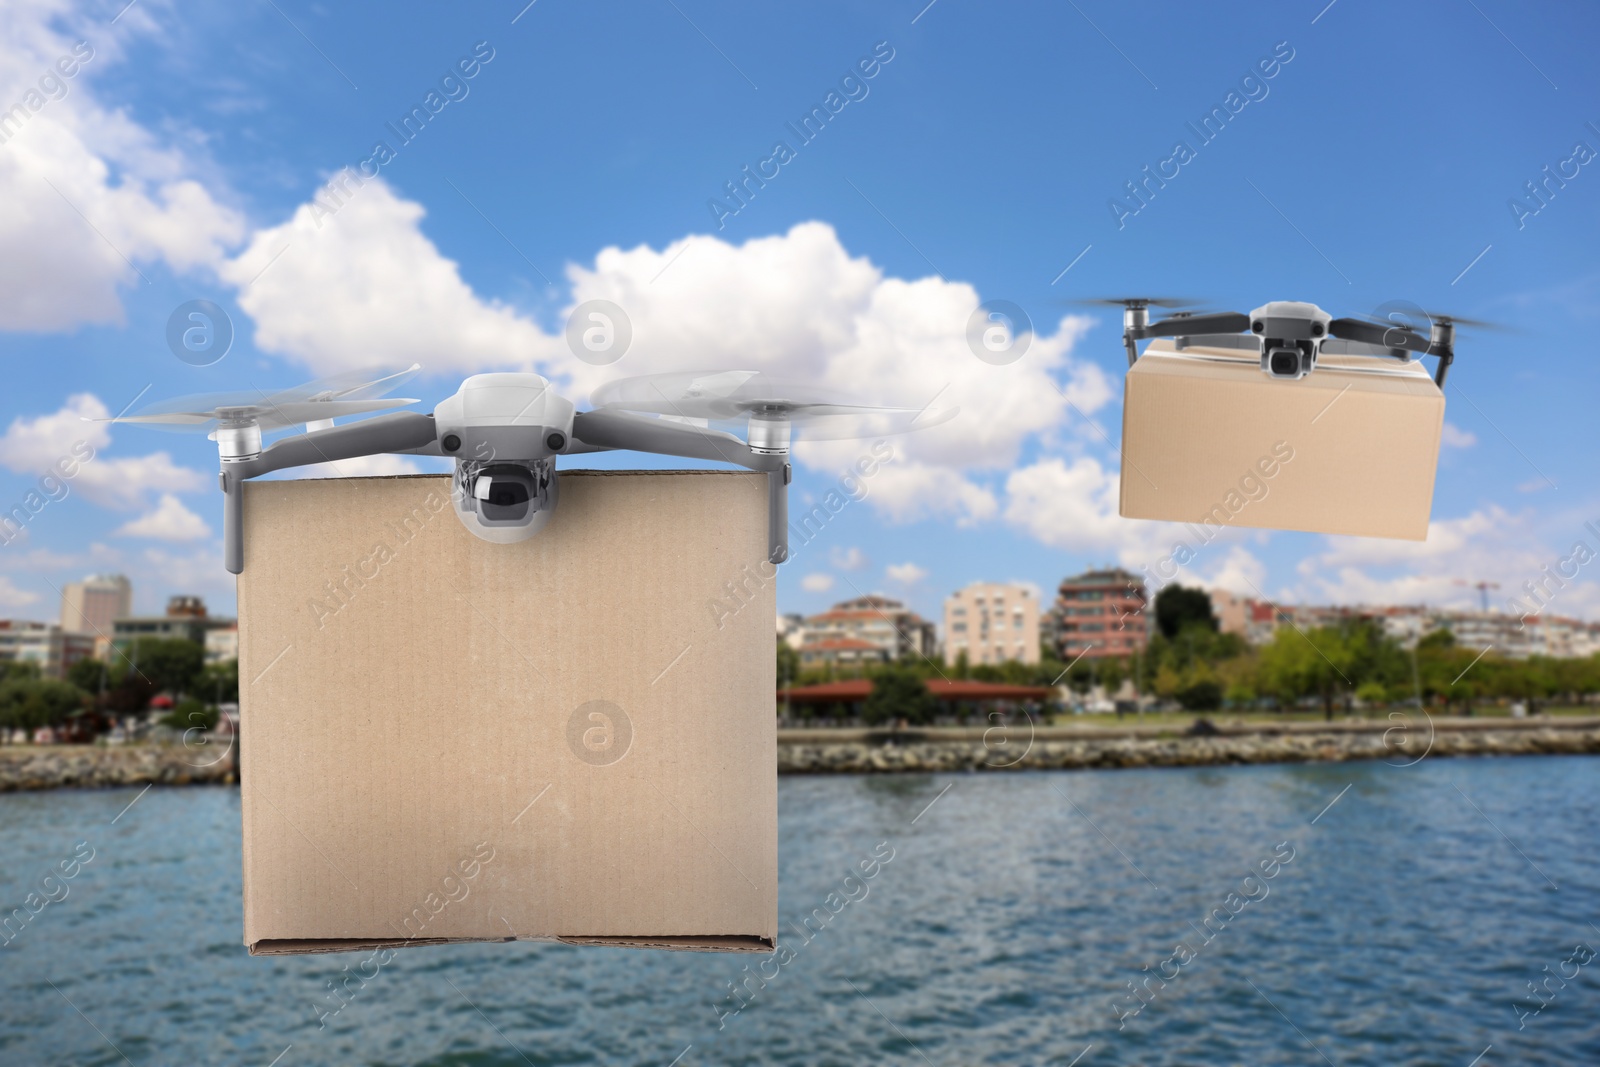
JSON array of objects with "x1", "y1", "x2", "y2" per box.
[{"x1": 778, "y1": 717, "x2": 1600, "y2": 774}]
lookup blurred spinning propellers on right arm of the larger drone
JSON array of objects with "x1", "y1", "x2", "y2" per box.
[{"x1": 594, "y1": 371, "x2": 958, "y2": 451}]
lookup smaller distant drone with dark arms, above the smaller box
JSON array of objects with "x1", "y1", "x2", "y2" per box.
[{"x1": 1080, "y1": 296, "x2": 1491, "y2": 389}]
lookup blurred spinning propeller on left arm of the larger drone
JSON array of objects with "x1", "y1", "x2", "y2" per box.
[{"x1": 94, "y1": 363, "x2": 422, "y2": 434}]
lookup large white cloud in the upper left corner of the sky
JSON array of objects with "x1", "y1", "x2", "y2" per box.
[{"x1": 0, "y1": 0, "x2": 243, "y2": 330}]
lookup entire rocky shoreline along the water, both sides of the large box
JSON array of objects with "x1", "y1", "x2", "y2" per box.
[{"x1": 0, "y1": 717, "x2": 1600, "y2": 793}]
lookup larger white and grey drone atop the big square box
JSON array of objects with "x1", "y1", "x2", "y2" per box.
[{"x1": 106, "y1": 363, "x2": 957, "y2": 574}]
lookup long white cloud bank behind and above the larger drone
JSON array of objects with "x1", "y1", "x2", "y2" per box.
[{"x1": 222, "y1": 207, "x2": 1114, "y2": 523}]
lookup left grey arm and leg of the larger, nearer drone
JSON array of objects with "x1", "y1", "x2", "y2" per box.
[{"x1": 221, "y1": 411, "x2": 437, "y2": 574}]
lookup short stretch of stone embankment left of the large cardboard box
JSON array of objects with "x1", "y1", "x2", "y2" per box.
[{"x1": 0, "y1": 741, "x2": 237, "y2": 793}]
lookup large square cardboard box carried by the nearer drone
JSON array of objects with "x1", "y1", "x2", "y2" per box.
[{"x1": 238, "y1": 472, "x2": 778, "y2": 955}]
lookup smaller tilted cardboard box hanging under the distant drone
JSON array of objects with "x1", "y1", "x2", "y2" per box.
[{"x1": 1120, "y1": 341, "x2": 1445, "y2": 541}]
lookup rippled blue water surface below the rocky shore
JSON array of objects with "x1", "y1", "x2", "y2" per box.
[{"x1": 0, "y1": 757, "x2": 1600, "y2": 1067}]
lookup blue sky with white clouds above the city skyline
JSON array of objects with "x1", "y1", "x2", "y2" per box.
[{"x1": 0, "y1": 0, "x2": 1600, "y2": 619}]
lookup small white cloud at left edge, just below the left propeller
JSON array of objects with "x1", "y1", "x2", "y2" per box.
[{"x1": 0, "y1": 395, "x2": 213, "y2": 510}]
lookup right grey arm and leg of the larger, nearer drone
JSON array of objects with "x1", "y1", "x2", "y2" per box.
[{"x1": 573, "y1": 411, "x2": 794, "y2": 563}]
